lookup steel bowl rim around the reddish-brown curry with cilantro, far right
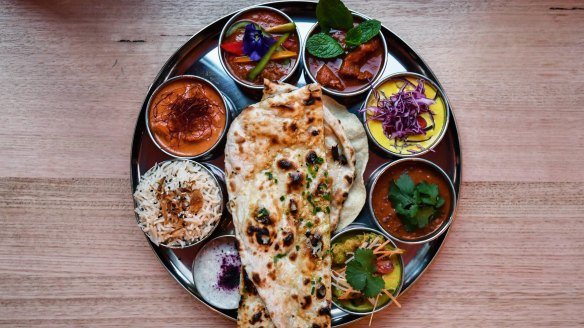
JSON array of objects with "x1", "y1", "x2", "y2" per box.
[{"x1": 367, "y1": 158, "x2": 456, "y2": 244}]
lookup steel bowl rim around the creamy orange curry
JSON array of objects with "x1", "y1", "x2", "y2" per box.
[{"x1": 145, "y1": 75, "x2": 232, "y2": 160}]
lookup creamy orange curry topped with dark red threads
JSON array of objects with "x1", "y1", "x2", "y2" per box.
[{"x1": 148, "y1": 78, "x2": 226, "y2": 156}]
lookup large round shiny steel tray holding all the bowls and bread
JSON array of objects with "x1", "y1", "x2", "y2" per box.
[{"x1": 131, "y1": 1, "x2": 462, "y2": 326}]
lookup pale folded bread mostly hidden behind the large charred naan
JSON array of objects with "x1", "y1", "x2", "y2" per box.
[{"x1": 262, "y1": 80, "x2": 369, "y2": 231}]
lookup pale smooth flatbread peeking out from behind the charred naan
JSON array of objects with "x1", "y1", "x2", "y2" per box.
[{"x1": 262, "y1": 80, "x2": 369, "y2": 231}]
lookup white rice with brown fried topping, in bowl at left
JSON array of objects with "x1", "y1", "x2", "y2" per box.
[{"x1": 134, "y1": 161, "x2": 223, "y2": 247}]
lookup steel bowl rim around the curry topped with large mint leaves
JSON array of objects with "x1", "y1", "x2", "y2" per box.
[{"x1": 302, "y1": 11, "x2": 387, "y2": 98}]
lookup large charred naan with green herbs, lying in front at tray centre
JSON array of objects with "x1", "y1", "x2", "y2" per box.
[{"x1": 225, "y1": 85, "x2": 332, "y2": 328}]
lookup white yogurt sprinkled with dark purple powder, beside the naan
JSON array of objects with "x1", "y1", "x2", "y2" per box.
[{"x1": 193, "y1": 236, "x2": 241, "y2": 310}]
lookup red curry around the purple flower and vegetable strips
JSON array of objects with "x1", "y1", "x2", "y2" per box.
[{"x1": 221, "y1": 9, "x2": 299, "y2": 85}]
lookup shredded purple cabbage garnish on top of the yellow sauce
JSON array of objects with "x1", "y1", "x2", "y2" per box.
[{"x1": 361, "y1": 79, "x2": 436, "y2": 145}]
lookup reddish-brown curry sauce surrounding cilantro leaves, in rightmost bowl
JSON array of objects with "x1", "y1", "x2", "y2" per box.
[{"x1": 371, "y1": 162, "x2": 452, "y2": 240}]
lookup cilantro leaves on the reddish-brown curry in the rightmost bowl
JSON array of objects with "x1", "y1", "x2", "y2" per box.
[{"x1": 389, "y1": 173, "x2": 444, "y2": 231}]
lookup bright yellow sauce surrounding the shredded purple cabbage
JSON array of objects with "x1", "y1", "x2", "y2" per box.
[{"x1": 366, "y1": 77, "x2": 447, "y2": 155}]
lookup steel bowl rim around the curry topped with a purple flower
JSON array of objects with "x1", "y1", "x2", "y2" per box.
[{"x1": 217, "y1": 6, "x2": 303, "y2": 93}]
